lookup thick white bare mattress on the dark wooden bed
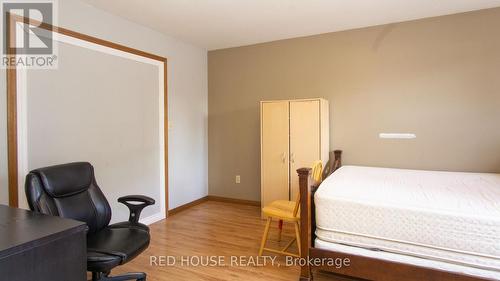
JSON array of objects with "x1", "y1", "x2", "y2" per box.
[{"x1": 314, "y1": 166, "x2": 500, "y2": 272}]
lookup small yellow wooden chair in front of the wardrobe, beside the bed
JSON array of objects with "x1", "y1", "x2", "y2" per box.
[{"x1": 259, "y1": 161, "x2": 323, "y2": 257}]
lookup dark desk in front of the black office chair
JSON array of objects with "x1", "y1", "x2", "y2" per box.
[{"x1": 0, "y1": 205, "x2": 87, "y2": 281}]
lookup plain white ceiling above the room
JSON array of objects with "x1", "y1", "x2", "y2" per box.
[{"x1": 83, "y1": 0, "x2": 500, "y2": 50}]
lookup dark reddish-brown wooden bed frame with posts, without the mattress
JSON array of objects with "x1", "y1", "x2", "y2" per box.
[{"x1": 297, "y1": 150, "x2": 490, "y2": 281}]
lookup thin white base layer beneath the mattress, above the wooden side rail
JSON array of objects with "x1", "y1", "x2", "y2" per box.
[{"x1": 314, "y1": 239, "x2": 500, "y2": 280}]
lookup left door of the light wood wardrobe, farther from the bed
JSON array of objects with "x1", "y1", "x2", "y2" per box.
[{"x1": 261, "y1": 101, "x2": 289, "y2": 206}]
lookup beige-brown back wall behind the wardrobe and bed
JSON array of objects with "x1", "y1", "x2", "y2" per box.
[{"x1": 208, "y1": 9, "x2": 500, "y2": 200}]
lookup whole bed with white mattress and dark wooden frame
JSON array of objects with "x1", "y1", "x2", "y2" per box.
[{"x1": 298, "y1": 151, "x2": 500, "y2": 281}]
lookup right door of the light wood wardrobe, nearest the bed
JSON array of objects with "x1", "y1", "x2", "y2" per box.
[{"x1": 290, "y1": 100, "x2": 321, "y2": 200}]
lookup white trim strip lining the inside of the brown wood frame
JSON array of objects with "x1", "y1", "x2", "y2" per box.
[{"x1": 16, "y1": 26, "x2": 166, "y2": 218}]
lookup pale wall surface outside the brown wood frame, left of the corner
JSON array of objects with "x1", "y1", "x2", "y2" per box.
[{"x1": 0, "y1": 0, "x2": 208, "y2": 214}]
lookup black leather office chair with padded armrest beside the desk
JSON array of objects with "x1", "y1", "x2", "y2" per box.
[{"x1": 25, "y1": 162, "x2": 155, "y2": 281}]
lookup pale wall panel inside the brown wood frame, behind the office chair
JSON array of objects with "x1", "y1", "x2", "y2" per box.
[{"x1": 24, "y1": 40, "x2": 165, "y2": 222}]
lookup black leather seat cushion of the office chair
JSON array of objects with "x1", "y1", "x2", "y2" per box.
[{"x1": 87, "y1": 225, "x2": 150, "y2": 272}]
